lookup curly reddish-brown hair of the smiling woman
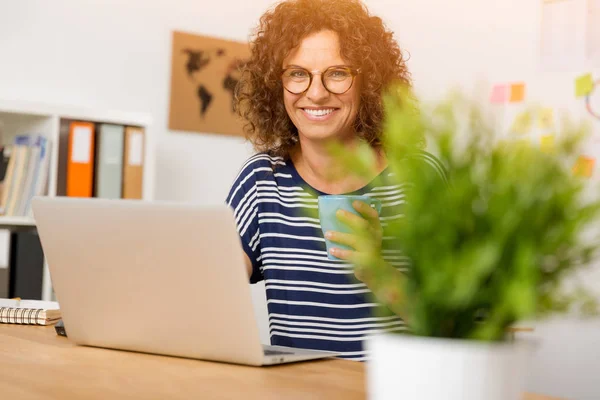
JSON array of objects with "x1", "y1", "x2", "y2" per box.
[{"x1": 236, "y1": 0, "x2": 410, "y2": 158}]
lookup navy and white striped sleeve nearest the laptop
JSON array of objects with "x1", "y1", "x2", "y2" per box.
[{"x1": 226, "y1": 162, "x2": 263, "y2": 283}]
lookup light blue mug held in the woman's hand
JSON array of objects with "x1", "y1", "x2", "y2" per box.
[{"x1": 319, "y1": 194, "x2": 381, "y2": 260}]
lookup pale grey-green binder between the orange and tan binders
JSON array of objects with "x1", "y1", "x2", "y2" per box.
[{"x1": 94, "y1": 124, "x2": 125, "y2": 199}]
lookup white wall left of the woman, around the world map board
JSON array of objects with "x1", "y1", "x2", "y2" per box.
[{"x1": 0, "y1": 0, "x2": 270, "y2": 348}]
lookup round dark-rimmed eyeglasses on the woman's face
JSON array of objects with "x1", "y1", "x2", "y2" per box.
[{"x1": 281, "y1": 66, "x2": 361, "y2": 94}]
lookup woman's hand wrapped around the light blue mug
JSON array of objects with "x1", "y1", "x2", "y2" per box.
[{"x1": 325, "y1": 200, "x2": 383, "y2": 282}]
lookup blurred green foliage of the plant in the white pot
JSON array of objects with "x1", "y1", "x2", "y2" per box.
[{"x1": 308, "y1": 86, "x2": 600, "y2": 341}]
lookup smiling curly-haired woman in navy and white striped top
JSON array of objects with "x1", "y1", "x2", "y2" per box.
[{"x1": 227, "y1": 0, "x2": 446, "y2": 360}]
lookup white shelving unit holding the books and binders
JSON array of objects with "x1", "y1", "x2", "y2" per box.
[{"x1": 0, "y1": 99, "x2": 155, "y2": 300}]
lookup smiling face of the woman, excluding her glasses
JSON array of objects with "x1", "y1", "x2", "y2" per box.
[{"x1": 283, "y1": 30, "x2": 360, "y2": 145}]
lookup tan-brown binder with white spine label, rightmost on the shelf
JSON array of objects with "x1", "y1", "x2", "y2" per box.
[{"x1": 123, "y1": 126, "x2": 145, "y2": 199}]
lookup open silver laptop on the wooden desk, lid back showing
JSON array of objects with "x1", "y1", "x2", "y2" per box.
[{"x1": 32, "y1": 197, "x2": 336, "y2": 366}]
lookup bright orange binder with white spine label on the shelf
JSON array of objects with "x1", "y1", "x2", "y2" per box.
[{"x1": 66, "y1": 121, "x2": 95, "y2": 197}]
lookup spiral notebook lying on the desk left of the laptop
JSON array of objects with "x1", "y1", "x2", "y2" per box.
[{"x1": 0, "y1": 299, "x2": 61, "y2": 325}]
